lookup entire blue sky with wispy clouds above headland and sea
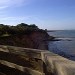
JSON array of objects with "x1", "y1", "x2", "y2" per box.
[{"x1": 0, "y1": 0, "x2": 75, "y2": 30}]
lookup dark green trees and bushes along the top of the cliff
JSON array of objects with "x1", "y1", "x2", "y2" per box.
[{"x1": 0, "y1": 23, "x2": 40, "y2": 36}]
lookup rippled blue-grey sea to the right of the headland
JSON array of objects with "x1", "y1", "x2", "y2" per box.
[{"x1": 48, "y1": 30, "x2": 75, "y2": 60}]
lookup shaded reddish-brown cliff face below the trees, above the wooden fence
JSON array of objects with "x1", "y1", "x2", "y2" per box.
[{"x1": 0, "y1": 31, "x2": 52, "y2": 50}]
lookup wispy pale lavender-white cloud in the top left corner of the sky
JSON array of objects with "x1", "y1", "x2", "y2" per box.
[{"x1": 0, "y1": 0, "x2": 33, "y2": 9}]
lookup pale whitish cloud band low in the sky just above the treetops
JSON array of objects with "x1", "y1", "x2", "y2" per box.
[{"x1": 0, "y1": 15, "x2": 41, "y2": 25}]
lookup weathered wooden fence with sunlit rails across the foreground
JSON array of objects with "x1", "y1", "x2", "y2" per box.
[{"x1": 0, "y1": 45, "x2": 75, "y2": 75}]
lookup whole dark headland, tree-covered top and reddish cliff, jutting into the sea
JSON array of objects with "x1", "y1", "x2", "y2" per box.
[{"x1": 0, "y1": 23, "x2": 53, "y2": 49}]
